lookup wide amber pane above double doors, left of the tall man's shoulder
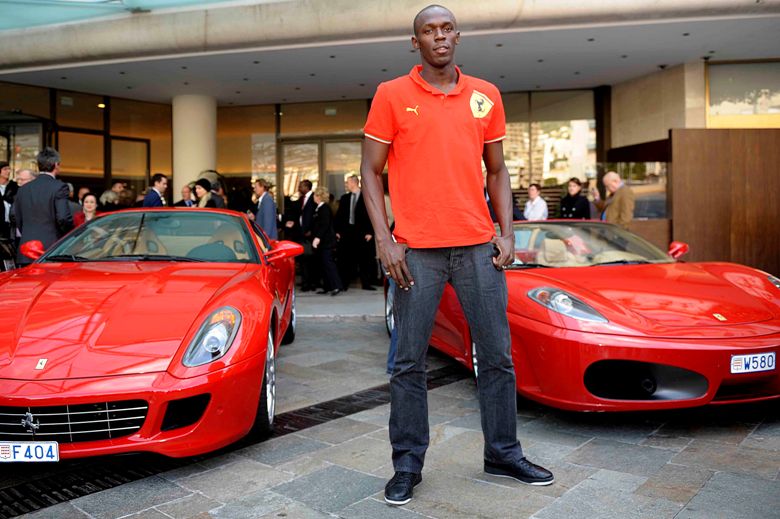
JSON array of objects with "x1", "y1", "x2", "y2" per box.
[{"x1": 281, "y1": 100, "x2": 368, "y2": 137}]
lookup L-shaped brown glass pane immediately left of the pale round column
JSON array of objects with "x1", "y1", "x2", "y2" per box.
[{"x1": 111, "y1": 98, "x2": 173, "y2": 176}]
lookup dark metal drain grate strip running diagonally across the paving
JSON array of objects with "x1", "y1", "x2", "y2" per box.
[{"x1": 0, "y1": 364, "x2": 470, "y2": 519}]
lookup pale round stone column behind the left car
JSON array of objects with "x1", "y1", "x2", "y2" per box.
[{"x1": 170, "y1": 95, "x2": 217, "y2": 198}]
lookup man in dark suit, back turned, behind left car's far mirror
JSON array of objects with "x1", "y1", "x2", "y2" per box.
[{"x1": 14, "y1": 147, "x2": 73, "y2": 265}]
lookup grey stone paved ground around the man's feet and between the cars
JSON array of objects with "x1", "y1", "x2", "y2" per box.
[{"x1": 19, "y1": 291, "x2": 780, "y2": 519}]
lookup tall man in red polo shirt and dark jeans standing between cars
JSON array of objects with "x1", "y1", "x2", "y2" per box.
[{"x1": 360, "y1": 5, "x2": 553, "y2": 505}]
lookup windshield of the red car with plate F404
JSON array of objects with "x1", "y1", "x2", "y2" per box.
[{"x1": 41, "y1": 209, "x2": 258, "y2": 263}]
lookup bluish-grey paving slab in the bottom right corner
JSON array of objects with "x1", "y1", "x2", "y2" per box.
[{"x1": 676, "y1": 472, "x2": 780, "y2": 519}]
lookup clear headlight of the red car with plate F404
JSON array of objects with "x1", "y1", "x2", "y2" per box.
[{"x1": 182, "y1": 306, "x2": 241, "y2": 368}]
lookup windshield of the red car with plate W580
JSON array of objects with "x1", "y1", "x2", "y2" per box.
[{"x1": 512, "y1": 221, "x2": 674, "y2": 268}]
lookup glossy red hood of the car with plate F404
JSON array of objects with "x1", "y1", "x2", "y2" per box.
[{"x1": 0, "y1": 262, "x2": 245, "y2": 380}]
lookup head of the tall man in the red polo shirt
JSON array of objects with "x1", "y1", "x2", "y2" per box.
[{"x1": 412, "y1": 4, "x2": 460, "y2": 68}]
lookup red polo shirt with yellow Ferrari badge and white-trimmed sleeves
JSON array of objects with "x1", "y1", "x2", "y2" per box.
[{"x1": 363, "y1": 65, "x2": 506, "y2": 248}]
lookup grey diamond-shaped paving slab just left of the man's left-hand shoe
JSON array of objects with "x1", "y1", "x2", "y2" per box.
[{"x1": 273, "y1": 465, "x2": 385, "y2": 513}]
